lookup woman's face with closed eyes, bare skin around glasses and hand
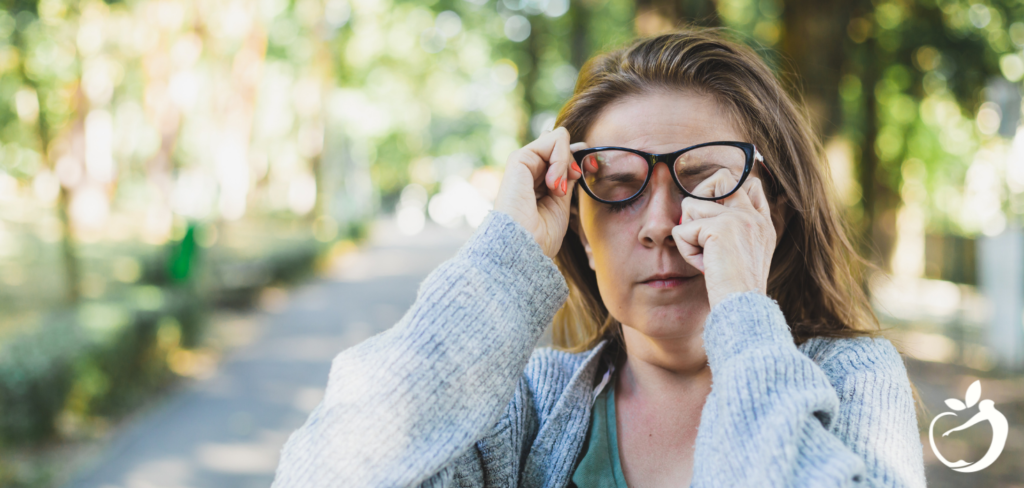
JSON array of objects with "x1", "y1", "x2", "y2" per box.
[{"x1": 578, "y1": 91, "x2": 750, "y2": 339}]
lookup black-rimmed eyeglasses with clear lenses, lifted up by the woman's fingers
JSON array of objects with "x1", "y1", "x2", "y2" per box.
[{"x1": 572, "y1": 141, "x2": 767, "y2": 204}]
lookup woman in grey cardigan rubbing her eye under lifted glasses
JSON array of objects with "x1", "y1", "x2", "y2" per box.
[{"x1": 274, "y1": 31, "x2": 925, "y2": 488}]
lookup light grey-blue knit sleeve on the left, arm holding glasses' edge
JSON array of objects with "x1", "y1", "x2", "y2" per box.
[{"x1": 273, "y1": 212, "x2": 568, "y2": 488}]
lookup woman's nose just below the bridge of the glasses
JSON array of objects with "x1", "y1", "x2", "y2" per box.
[{"x1": 637, "y1": 164, "x2": 682, "y2": 248}]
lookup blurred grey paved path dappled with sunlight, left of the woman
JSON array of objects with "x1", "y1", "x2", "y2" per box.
[{"x1": 69, "y1": 217, "x2": 469, "y2": 488}]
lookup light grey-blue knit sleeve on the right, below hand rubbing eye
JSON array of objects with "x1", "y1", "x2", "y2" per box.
[{"x1": 691, "y1": 292, "x2": 925, "y2": 487}]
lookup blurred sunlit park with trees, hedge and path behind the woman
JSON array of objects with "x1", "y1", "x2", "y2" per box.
[{"x1": 0, "y1": 0, "x2": 1024, "y2": 487}]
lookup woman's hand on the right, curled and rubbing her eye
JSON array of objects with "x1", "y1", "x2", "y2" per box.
[{"x1": 672, "y1": 169, "x2": 775, "y2": 308}]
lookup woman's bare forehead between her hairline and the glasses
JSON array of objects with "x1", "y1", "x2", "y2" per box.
[{"x1": 584, "y1": 90, "x2": 746, "y2": 152}]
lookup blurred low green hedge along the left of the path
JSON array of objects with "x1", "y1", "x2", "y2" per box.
[{"x1": 0, "y1": 230, "x2": 322, "y2": 448}]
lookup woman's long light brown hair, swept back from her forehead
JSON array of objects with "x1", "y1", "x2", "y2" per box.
[{"x1": 552, "y1": 29, "x2": 881, "y2": 352}]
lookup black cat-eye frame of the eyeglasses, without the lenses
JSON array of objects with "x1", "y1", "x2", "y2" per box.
[{"x1": 572, "y1": 141, "x2": 764, "y2": 204}]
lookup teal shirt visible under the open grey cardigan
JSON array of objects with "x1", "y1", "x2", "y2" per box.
[{"x1": 572, "y1": 374, "x2": 627, "y2": 488}]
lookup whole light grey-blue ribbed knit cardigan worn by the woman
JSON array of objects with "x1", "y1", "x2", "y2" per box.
[{"x1": 273, "y1": 212, "x2": 925, "y2": 488}]
